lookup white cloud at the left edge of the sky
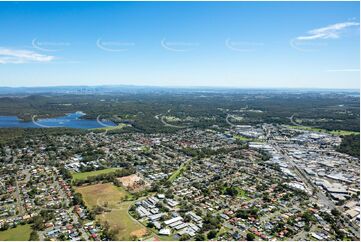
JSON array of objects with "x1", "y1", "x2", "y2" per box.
[{"x1": 0, "y1": 48, "x2": 55, "y2": 64}]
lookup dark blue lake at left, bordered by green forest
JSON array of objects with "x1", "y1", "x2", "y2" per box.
[{"x1": 0, "y1": 112, "x2": 116, "y2": 129}]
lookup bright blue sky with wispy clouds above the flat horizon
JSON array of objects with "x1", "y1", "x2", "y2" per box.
[{"x1": 0, "y1": 2, "x2": 360, "y2": 89}]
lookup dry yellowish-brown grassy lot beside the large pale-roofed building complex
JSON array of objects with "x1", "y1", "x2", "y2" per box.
[{"x1": 76, "y1": 183, "x2": 147, "y2": 240}]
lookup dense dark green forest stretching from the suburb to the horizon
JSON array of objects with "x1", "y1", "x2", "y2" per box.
[{"x1": 0, "y1": 90, "x2": 360, "y2": 133}]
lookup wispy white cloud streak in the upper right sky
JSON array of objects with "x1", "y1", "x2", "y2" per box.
[{"x1": 296, "y1": 22, "x2": 360, "y2": 40}]
